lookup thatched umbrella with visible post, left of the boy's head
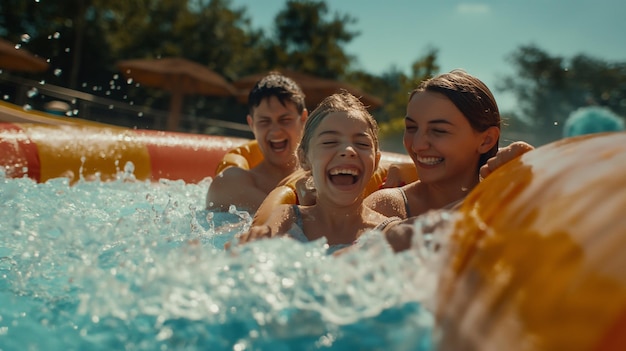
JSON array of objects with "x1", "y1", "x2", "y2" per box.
[{"x1": 117, "y1": 57, "x2": 237, "y2": 130}]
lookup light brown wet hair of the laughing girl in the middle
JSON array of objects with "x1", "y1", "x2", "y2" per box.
[{"x1": 298, "y1": 91, "x2": 378, "y2": 161}]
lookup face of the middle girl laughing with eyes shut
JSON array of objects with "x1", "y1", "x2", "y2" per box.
[{"x1": 303, "y1": 112, "x2": 380, "y2": 205}]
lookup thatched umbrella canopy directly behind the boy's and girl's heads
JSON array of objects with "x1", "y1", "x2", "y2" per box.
[{"x1": 233, "y1": 69, "x2": 383, "y2": 109}]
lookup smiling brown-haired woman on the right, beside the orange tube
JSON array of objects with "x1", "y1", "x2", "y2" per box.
[{"x1": 365, "y1": 70, "x2": 500, "y2": 250}]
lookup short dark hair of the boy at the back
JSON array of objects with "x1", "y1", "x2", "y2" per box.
[{"x1": 248, "y1": 71, "x2": 306, "y2": 116}]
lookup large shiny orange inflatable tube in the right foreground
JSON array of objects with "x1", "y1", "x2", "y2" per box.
[{"x1": 436, "y1": 133, "x2": 626, "y2": 351}]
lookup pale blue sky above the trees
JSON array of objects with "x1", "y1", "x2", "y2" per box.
[{"x1": 232, "y1": 0, "x2": 626, "y2": 110}]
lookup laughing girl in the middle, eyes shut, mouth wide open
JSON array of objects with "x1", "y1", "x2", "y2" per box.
[{"x1": 239, "y1": 93, "x2": 387, "y2": 252}]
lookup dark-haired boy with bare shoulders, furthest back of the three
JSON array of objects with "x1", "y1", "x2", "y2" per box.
[{"x1": 206, "y1": 72, "x2": 308, "y2": 213}]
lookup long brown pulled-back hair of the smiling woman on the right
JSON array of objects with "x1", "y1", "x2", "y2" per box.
[{"x1": 409, "y1": 69, "x2": 501, "y2": 169}]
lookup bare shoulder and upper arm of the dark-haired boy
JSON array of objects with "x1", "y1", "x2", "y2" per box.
[{"x1": 206, "y1": 167, "x2": 267, "y2": 212}]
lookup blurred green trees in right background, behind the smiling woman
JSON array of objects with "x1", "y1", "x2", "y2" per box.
[{"x1": 498, "y1": 46, "x2": 626, "y2": 144}]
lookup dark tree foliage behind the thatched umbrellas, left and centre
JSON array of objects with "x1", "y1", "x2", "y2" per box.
[{"x1": 0, "y1": 0, "x2": 437, "y2": 131}]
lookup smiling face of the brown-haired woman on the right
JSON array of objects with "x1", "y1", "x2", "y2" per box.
[{"x1": 403, "y1": 91, "x2": 493, "y2": 186}]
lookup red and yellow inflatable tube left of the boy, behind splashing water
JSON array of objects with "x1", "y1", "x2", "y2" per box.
[{"x1": 0, "y1": 123, "x2": 249, "y2": 183}]
